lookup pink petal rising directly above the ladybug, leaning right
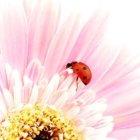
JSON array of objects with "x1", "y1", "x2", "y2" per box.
[{"x1": 69, "y1": 11, "x2": 107, "y2": 61}]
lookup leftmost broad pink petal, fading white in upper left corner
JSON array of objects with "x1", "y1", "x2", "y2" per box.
[{"x1": 0, "y1": 0, "x2": 27, "y2": 72}]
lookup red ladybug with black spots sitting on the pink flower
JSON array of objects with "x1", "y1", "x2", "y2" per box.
[{"x1": 66, "y1": 61, "x2": 92, "y2": 85}]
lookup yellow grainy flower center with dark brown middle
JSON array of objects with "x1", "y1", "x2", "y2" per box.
[{"x1": 0, "y1": 105, "x2": 82, "y2": 140}]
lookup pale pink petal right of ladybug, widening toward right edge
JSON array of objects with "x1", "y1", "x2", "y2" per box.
[{"x1": 95, "y1": 49, "x2": 140, "y2": 93}]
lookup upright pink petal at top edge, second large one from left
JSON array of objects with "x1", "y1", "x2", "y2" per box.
[{"x1": 26, "y1": 0, "x2": 59, "y2": 62}]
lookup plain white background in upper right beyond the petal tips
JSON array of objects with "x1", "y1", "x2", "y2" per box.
[{"x1": 61, "y1": 0, "x2": 140, "y2": 59}]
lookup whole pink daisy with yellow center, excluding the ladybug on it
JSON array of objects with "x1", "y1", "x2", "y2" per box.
[{"x1": 0, "y1": 0, "x2": 139, "y2": 140}]
